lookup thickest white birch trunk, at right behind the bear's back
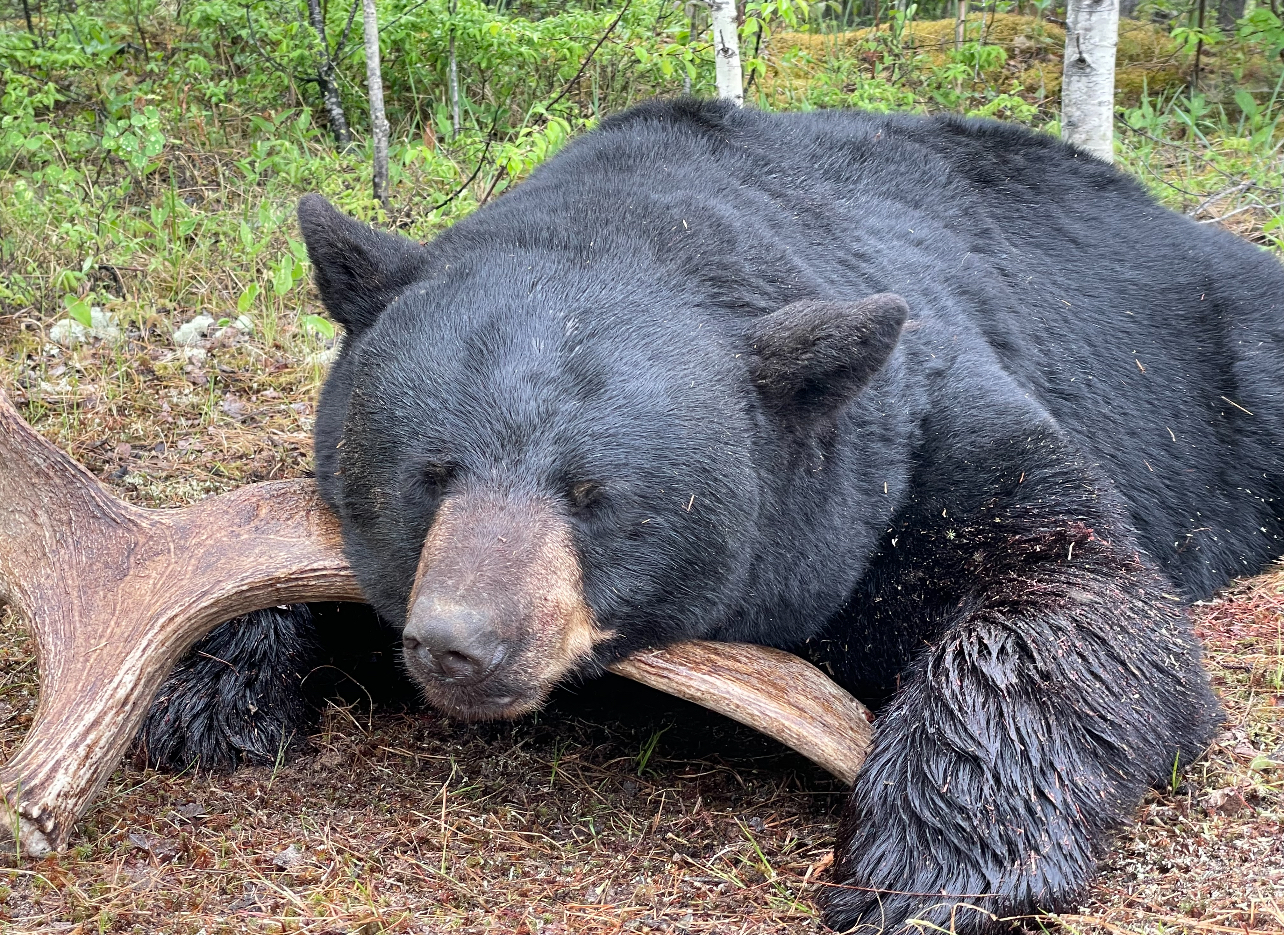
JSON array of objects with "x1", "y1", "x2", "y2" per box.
[{"x1": 1061, "y1": 0, "x2": 1120, "y2": 162}]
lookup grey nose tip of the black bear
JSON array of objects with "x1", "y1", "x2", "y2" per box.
[{"x1": 402, "y1": 601, "x2": 507, "y2": 682}]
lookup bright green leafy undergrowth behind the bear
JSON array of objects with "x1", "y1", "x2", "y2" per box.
[{"x1": 0, "y1": 0, "x2": 1284, "y2": 328}]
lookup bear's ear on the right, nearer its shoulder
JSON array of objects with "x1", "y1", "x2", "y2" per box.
[{"x1": 749, "y1": 293, "x2": 909, "y2": 426}]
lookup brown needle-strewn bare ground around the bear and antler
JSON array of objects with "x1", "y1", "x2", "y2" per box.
[{"x1": 0, "y1": 308, "x2": 1284, "y2": 935}]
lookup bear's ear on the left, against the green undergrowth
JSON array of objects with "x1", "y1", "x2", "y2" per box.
[{"x1": 299, "y1": 195, "x2": 428, "y2": 335}]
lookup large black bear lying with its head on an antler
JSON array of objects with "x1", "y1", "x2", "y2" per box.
[{"x1": 140, "y1": 100, "x2": 1284, "y2": 932}]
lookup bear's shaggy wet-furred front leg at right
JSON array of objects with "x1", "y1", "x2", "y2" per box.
[{"x1": 822, "y1": 530, "x2": 1221, "y2": 935}]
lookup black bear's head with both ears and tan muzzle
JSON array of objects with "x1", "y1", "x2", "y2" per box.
[{"x1": 299, "y1": 197, "x2": 907, "y2": 718}]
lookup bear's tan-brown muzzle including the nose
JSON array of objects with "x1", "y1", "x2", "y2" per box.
[{"x1": 402, "y1": 489, "x2": 610, "y2": 721}]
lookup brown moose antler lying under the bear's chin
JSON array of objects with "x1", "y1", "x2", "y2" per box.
[{"x1": 0, "y1": 390, "x2": 871, "y2": 857}]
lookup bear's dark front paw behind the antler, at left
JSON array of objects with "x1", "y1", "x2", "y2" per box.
[{"x1": 134, "y1": 605, "x2": 316, "y2": 772}]
